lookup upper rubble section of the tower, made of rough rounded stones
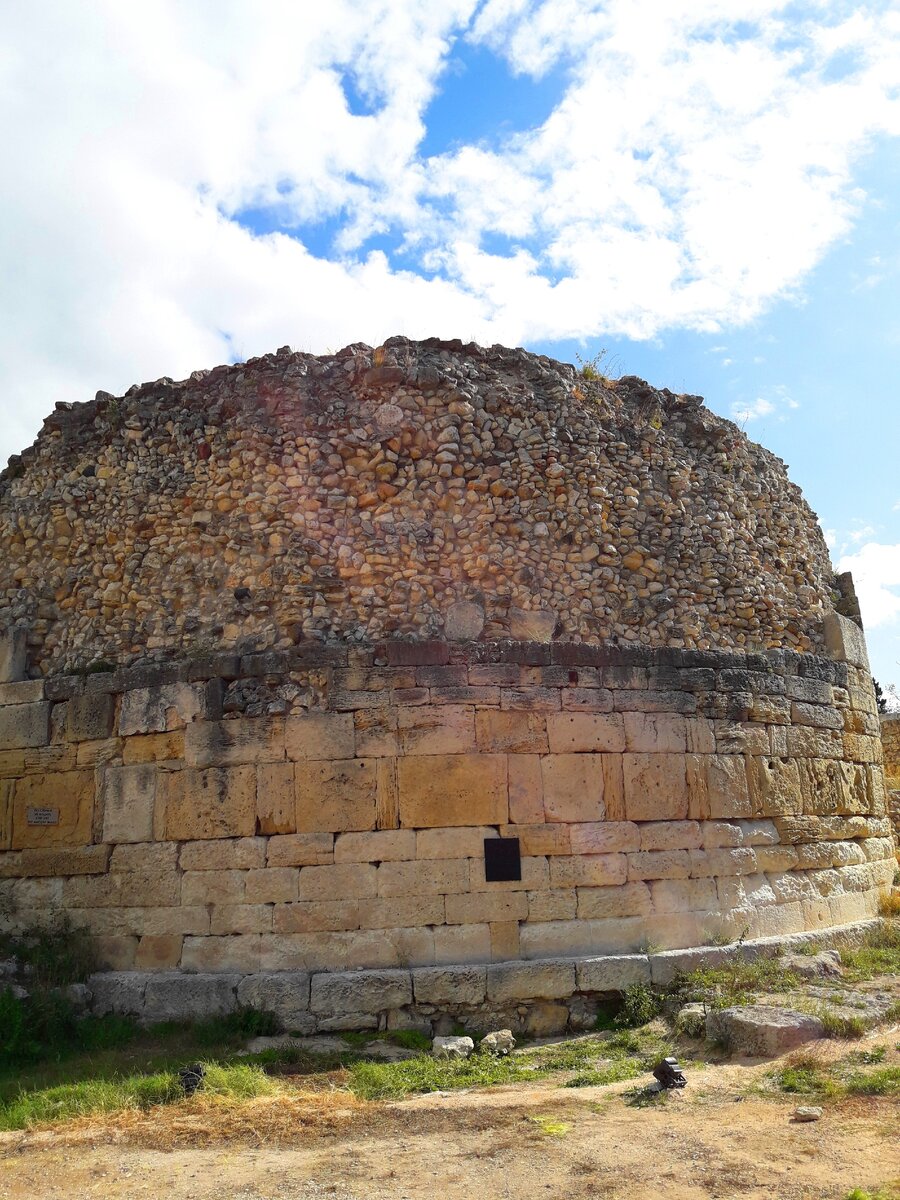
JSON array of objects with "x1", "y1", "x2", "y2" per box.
[{"x1": 0, "y1": 337, "x2": 841, "y2": 674}]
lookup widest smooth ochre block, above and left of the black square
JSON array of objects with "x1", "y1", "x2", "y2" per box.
[{"x1": 397, "y1": 754, "x2": 509, "y2": 829}]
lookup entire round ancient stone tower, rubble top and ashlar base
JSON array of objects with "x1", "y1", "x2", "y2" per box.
[{"x1": 0, "y1": 337, "x2": 894, "y2": 1030}]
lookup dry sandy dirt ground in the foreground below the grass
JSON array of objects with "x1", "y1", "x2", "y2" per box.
[{"x1": 0, "y1": 1051, "x2": 900, "y2": 1200}]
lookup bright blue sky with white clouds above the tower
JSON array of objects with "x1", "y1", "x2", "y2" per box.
[{"x1": 0, "y1": 0, "x2": 900, "y2": 685}]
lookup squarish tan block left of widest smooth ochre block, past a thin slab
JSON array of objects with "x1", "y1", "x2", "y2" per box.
[{"x1": 295, "y1": 758, "x2": 378, "y2": 833}]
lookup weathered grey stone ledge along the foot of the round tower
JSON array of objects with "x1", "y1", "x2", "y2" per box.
[{"x1": 82, "y1": 920, "x2": 878, "y2": 1033}]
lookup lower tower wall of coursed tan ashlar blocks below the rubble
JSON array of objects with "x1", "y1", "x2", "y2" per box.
[{"x1": 0, "y1": 617, "x2": 894, "y2": 1027}]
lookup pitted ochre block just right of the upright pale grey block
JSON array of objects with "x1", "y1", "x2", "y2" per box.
[{"x1": 156, "y1": 767, "x2": 257, "y2": 841}]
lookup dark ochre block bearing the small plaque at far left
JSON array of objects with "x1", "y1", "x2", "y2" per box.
[{"x1": 11, "y1": 770, "x2": 95, "y2": 850}]
